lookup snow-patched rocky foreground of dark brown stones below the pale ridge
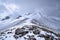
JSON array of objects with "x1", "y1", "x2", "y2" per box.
[{"x1": 0, "y1": 25, "x2": 60, "y2": 40}]
